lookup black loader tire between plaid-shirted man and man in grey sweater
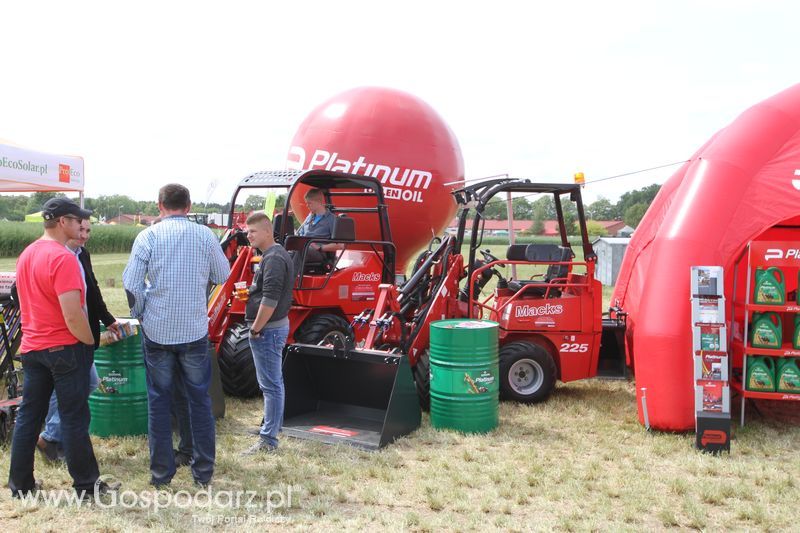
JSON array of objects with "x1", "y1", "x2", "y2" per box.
[{"x1": 219, "y1": 322, "x2": 261, "y2": 398}]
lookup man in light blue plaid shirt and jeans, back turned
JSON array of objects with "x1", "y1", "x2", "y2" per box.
[{"x1": 122, "y1": 184, "x2": 230, "y2": 487}]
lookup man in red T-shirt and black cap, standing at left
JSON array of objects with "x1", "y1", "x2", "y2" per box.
[{"x1": 8, "y1": 198, "x2": 117, "y2": 497}]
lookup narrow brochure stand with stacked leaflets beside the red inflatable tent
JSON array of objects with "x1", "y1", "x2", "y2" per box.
[{"x1": 691, "y1": 266, "x2": 731, "y2": 452}]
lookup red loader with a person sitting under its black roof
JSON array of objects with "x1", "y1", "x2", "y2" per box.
[{"x1": 208, "y1": 170, "x2": 395, "y2": 397}]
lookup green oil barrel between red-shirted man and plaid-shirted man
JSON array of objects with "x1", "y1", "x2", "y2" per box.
[{"x1": 89, "y1": 324, "x2": 147, "y2": 437}]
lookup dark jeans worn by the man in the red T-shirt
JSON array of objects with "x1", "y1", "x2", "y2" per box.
[{"x1": 8, "y1": 342, "x2": 100, "y2": 495}]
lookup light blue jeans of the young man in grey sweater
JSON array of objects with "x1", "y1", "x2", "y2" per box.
[{"x1": 250, "y1": 326, "x2": 289, "y2": 446}]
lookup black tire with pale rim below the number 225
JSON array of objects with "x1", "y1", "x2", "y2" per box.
[{"x1": 500, "y1": 341, "x2": 557, "y2": 403}]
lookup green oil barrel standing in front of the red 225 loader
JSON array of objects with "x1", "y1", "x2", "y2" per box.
[{"x1": 430, "y1": 319, "x2": 500, "y2": 433}]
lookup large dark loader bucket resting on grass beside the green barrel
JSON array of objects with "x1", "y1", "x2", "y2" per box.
[{"x1": 283, "y1": 344, "x2": 421, "y2": 450}]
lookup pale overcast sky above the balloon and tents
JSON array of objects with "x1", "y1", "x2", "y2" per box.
[{"x1": 0, "y1": 0, "x2": 800, "y2": 202}]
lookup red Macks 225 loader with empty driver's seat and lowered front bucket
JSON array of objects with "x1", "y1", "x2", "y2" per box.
[{"x1": 283, "y1": 179, "x2": 625, "y2": 449}]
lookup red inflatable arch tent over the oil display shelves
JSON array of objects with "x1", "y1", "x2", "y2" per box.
[{"x1": 612, "y1": 84, "x2": 800, "y2": 431}]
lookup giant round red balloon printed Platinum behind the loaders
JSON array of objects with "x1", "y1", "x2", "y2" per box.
[{"x1": 287, "y1": 87, "x2": 464, "y2": 273}]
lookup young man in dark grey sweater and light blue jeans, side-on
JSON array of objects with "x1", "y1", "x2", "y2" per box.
[{"x1": 244, "y1": 211, "x2": 294, "y2": 455}]
